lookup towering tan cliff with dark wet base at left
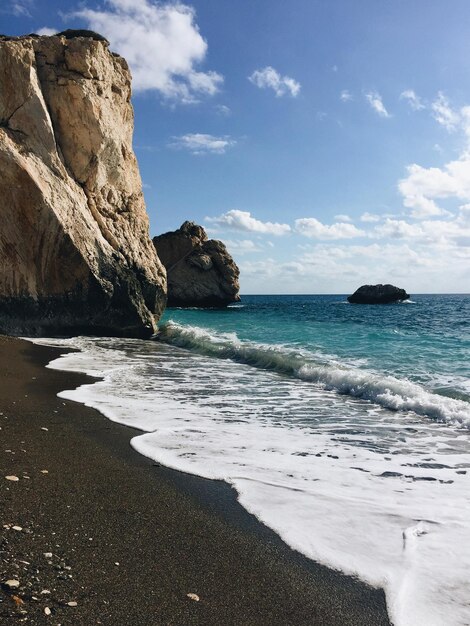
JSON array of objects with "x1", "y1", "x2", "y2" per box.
[{"x1": 0, "y1": 31, "x2": 166, "y2": 337}]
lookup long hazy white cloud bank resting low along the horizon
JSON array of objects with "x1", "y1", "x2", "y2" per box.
[{"x1": 240, "y1": 210, "x2": 470, "y2": 293}]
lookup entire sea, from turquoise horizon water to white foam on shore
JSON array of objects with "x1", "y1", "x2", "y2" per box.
[{"x1": 30, "y1": 295, "x2": 470, "y2": 626}]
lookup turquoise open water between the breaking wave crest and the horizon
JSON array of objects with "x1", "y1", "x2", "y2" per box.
[{"x1": 161, "y1": 294, "x2": 470, "y2": 423}]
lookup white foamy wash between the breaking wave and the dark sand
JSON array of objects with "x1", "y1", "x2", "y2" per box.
[{"x1": 28, "y1": 338, "x2": 470, "y2": 626}]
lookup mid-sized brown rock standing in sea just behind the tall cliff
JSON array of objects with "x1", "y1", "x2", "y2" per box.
[{"x1": 153, "y1": 222, "x2": 240, "y2": 307}]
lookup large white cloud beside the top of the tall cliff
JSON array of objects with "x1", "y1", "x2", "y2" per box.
[{"x1": 67, "y1": 0, "x2": 223, "y2": 103}]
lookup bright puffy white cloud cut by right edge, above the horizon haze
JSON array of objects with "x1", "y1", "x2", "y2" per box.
[{"x1": 398, "y1": 155, "x2": 470, "y2": 219}]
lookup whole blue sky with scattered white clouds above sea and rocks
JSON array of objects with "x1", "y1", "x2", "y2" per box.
[{"x1": 0, "y1": 0, "x2": 470, "y2": 294}]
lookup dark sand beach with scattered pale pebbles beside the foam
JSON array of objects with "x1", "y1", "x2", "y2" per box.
[{"x1": 0, "y1": 337, "x2": 389, "y2": 626}]
